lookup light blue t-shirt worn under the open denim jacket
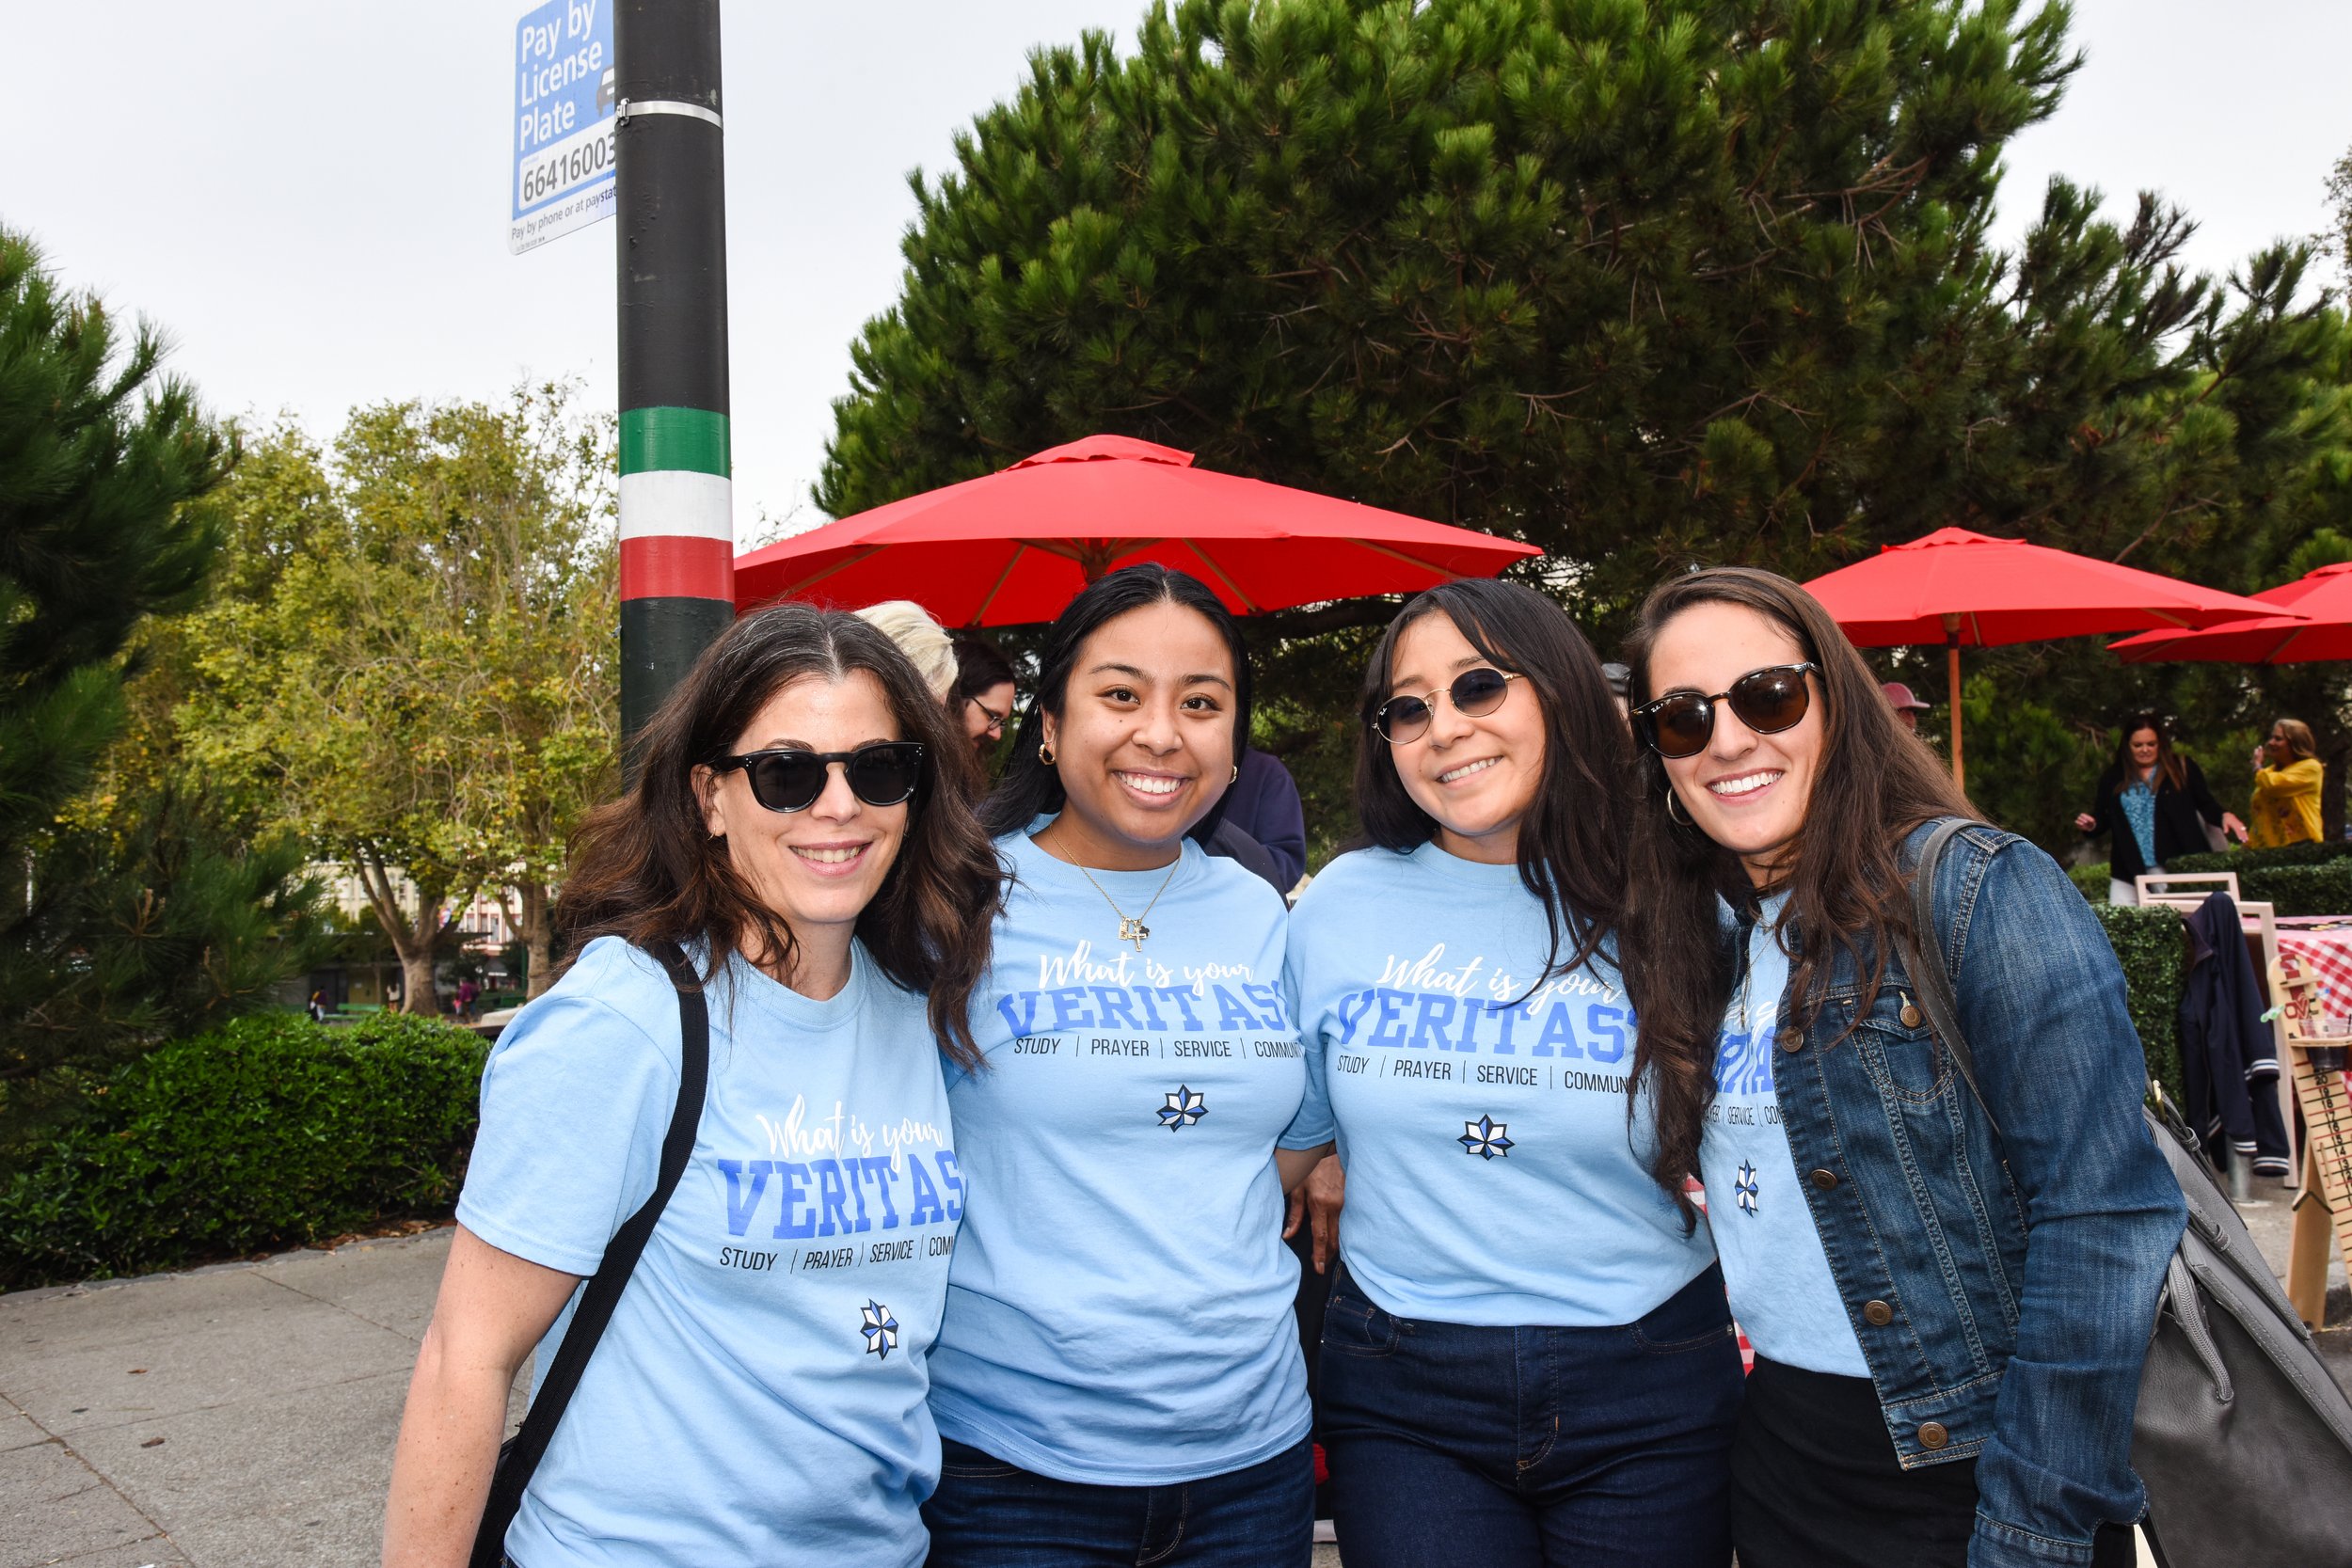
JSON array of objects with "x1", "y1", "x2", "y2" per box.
[{"x1": 1698, "y1": 895, "x2": 1870, "y2": 1378}]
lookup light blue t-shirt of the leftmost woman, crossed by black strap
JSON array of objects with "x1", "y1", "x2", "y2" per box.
[{"x1": 456, "y1": 938, "x2": 964, "y2": 1568}]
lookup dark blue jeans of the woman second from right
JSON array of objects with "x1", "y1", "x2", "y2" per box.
[{"x1": 1322, "y1": 1267, "x2": 1740, "y2": 1568}]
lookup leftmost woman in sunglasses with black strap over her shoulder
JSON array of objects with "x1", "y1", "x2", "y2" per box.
[{"x1": 384, "y1": 604, "x2": 1002, "y2": 1568}]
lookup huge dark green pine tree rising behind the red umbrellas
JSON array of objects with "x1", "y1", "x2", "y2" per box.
[{"x1": 817, "y1": 0, "x2": 2352, "y2": 860}]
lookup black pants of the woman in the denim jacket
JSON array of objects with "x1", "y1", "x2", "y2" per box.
[{"x1": 1731, "y1": 1356, "x2": 2138, "y2": 1568}]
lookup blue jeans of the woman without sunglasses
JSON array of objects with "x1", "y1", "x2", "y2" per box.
[{"x1": 922, "y1": 1441, "x2": 1315, "y2": 1568}]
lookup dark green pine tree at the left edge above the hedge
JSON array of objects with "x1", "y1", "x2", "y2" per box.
[{"x1": 0, "y1": 230, "x2": 309, "y2": 1104}]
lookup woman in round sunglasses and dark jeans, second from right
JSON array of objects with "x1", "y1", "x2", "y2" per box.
[{"x1": 1289, "y1": 580, "x2": 1740, "y2": 1568}]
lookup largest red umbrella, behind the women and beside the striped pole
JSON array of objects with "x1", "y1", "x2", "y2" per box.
[{"x1": 737, "y1": 435, "x2": 1543, "y2": 626}]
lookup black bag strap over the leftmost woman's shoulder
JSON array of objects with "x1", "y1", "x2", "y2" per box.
[{"x1": 469, "y1": 942, "x2": 710, "y2": 1568}]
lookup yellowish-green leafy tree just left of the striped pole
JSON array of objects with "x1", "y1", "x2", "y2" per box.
[{"x1": 179, "y1": 388, "x2": 616, "y2": 1013}]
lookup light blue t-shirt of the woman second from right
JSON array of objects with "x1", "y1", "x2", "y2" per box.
[{"x1": 1289, "y1": 844, "x2": 1712, "y2": 1326}]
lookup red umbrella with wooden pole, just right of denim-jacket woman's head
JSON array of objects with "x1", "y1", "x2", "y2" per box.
[{"x1": 1806, "y1": 529, "x2": 2280, "y2": 783}]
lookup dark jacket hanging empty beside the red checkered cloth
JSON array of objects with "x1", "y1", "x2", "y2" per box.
[{"x1": 2181, "y1": 894, "x2": 2289, "y2": 1180}]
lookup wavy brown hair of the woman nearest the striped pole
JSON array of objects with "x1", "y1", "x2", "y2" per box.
[{"x1": 555, "y1": 604, "x2": 1005, "y2": 1068}]
